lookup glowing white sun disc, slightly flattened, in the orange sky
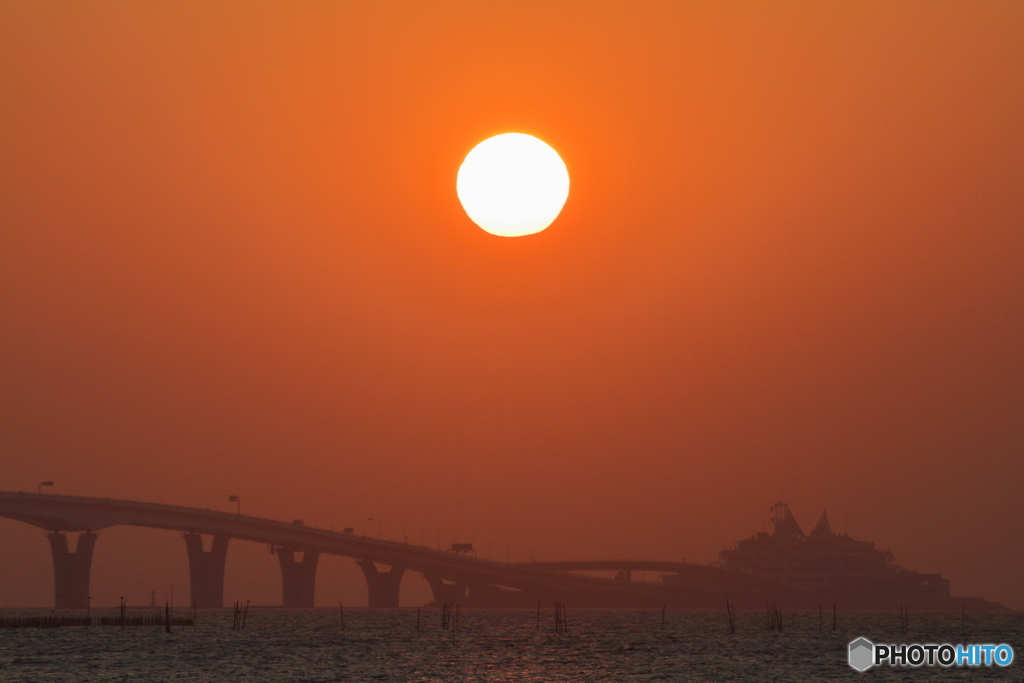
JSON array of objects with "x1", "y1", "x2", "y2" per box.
[{"x1": 456, "y1": 133, "x2": 569, "y2": 238}]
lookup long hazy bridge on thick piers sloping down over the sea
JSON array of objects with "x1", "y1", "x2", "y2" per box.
[{"x1": 0, "y1": 492, "x2": 765, "y2": 609}]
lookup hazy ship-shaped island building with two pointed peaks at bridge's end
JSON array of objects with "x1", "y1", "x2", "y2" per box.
[{"x1": 662, "y1": 503, "x2": 1005, "y2": 611}]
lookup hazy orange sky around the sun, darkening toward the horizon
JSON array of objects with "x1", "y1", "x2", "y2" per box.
[{"x1": 0, "y1": 0, "x2": 1024, "y2": 607}]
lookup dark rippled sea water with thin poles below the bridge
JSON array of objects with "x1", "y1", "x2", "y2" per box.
[{"x1": 0, "y1": 605, "x2": 1024, "y2": 683}]
